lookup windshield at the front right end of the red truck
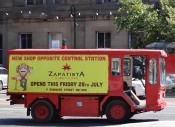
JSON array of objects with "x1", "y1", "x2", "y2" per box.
[{"x1": 160, "y1": 58, "x2": 166, "y2": 85}]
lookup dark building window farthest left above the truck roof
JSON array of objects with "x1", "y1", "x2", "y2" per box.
[{"x1": 19, "y1": 33, "x2": 32, "y2": 49}]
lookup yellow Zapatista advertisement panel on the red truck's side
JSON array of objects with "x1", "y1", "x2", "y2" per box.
[{"x1": 8, "y1": 54, "x2": 108, "y2": 94}]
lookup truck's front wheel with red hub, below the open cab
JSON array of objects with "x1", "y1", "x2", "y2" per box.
[{"x1": 106, "y1": 100, "x2": 131, "y2": 122}]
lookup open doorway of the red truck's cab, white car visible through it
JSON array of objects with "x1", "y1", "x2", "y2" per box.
[{"x1": 124, "y1": 56, "x2": 145, "y2": 99}]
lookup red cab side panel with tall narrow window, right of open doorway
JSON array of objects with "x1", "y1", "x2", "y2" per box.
[{"x1": 145, "y1": 57, "x2": 159, "y2": 110}]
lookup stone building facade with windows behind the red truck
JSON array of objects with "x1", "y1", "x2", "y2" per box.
[{"x1": 0, "y1": 0, "x2": 129, "y2": 66}]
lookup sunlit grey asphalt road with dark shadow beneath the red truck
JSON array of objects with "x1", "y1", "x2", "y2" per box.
[{"x1": 0, "y1": 91, "x2": 175, "y2": 127}]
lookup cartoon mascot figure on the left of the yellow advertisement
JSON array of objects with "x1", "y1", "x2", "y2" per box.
[{"x1": 15, "y1": 63, "x2": 32, "y2": 91}]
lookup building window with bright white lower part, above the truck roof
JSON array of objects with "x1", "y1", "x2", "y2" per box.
[{"x1": 48, "y1": 33, "x2": 62, "y2": 48}]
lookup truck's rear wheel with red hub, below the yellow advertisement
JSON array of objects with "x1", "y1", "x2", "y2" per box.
[{"x1": 31, "y1": 100, "x2": 55, "y2": 123}]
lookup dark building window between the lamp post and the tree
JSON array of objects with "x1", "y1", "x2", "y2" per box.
[{"x1": 96, "y1": 32, "x2": 111, "y2": 48}]
